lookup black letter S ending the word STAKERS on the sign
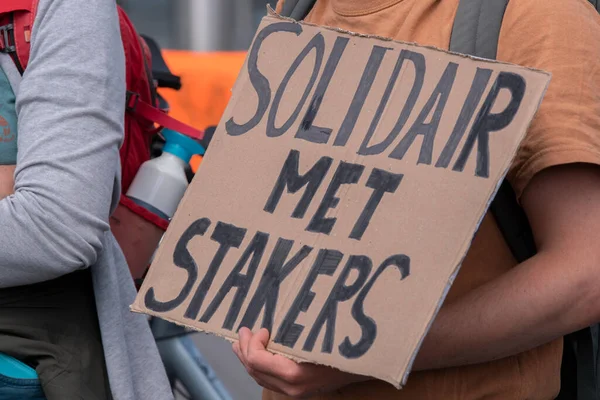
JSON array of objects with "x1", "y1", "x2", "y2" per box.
[{"x1": 339, "y1": 254, "x2": 410, "y2": 359}]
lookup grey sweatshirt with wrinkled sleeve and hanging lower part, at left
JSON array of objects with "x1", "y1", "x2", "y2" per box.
[{"x1": 0, "y1": 0, "x2": 173, "y2": 400}]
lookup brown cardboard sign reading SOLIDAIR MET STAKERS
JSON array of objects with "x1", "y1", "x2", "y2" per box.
[{"x1": 132, "y1": 14, "x2": 549, "y2": 387}]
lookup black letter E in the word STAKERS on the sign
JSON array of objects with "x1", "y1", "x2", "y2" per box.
[{"x1": 275, "y1": 249, "x2": 344, "y2": 348}]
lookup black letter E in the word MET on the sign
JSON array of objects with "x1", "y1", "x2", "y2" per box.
[{"x1": 306, "y1": 161, "x2": 365, "y2": 235}]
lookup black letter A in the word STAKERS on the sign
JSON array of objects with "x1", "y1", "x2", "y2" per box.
[{"x1": 200, "y1": 232, "x2": 269, "y2": 330}]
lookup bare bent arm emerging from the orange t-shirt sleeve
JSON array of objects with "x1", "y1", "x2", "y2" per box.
[{"x1": 415, "y1": 165, "x2": 600, "y2": 369}]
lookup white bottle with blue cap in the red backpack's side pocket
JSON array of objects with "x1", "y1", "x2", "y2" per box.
[{"x1": 127, "y1": 128, "x2": 204, "y2": 220}]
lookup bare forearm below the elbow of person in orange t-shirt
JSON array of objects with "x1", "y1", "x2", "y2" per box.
[{"x1": 415, "y1": 247, "x2": 600, "y2": 370}]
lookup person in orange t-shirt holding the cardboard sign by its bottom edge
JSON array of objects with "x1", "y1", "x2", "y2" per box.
[{"x1": 233, "y1": 0, "x2": 600, "y2": 400}]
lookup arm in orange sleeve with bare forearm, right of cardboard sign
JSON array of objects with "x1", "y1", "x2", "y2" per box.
[{"x1": 416, "y1": 0, "x2": 600, "y2": 369}]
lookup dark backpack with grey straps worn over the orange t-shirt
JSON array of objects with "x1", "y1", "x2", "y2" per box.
[{"x1": 281, "y1": 0, "x2": 600, "y2": 400}]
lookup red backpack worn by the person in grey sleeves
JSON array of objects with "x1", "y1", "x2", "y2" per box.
[{"x1": 0, "y1": 0, "x2": 204, "y2": 264}]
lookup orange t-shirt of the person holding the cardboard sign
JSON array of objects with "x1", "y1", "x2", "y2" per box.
[{"x1": 263, "y1": 0, "x2": 600, "y2": 400}]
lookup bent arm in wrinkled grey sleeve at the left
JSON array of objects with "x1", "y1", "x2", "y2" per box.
[{"x1": 0, "y1": 0, "x2": 125, "y2": 287}]
